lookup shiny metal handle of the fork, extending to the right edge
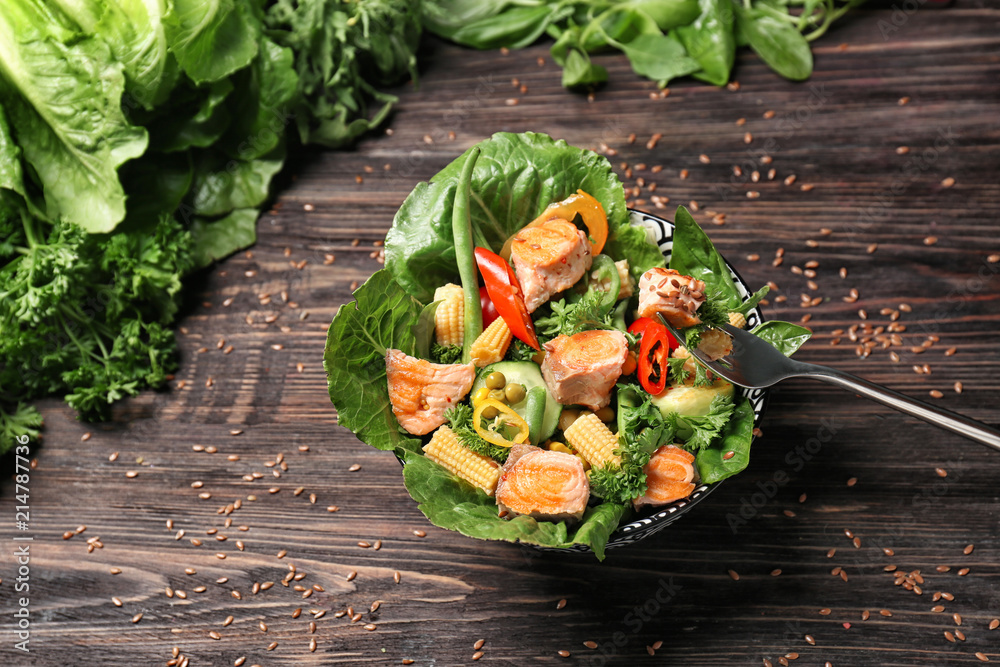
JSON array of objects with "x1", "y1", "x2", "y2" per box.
[{"x1": 796, "y1": 364, "x2": 1000, "y2": 450}]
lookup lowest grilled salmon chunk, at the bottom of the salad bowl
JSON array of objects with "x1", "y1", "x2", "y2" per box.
[{"x1": 496, "y1": 444, "x2": 590, "y2": 521}]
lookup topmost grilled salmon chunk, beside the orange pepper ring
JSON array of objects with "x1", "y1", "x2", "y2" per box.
[{"x1": 510, "y1": 218, "x2": 594, "y2": 313}]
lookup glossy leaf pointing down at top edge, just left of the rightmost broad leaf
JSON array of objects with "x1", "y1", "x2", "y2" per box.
[{"x1": 674, "y1": 0, "x2": 736, "y2": 86}]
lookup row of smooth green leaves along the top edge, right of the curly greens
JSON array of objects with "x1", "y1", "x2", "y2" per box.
[{"x1": 423, "y1": 0, "x2": 864, "y2": 88}]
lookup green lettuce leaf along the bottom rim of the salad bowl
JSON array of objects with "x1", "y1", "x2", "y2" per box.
[{"x1": 403, "y1": 451, "x2": 628, "y2": 560}]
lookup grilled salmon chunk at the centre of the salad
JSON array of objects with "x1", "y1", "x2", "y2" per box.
[{"x1": 542, "y1": 330, "x2": 628, "y2": 411}]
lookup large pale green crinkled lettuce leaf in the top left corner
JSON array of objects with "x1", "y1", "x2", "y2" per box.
[{"x1": 0, "y1": 2, "x2": 148, "y2": 232}]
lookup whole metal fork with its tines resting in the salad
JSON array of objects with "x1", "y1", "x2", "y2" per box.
[{"x1": 660, "y1": 315, "x2": 1000, "y2": 450}]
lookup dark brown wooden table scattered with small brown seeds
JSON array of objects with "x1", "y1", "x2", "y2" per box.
[{"x1": 7, "y1": 2, "x2": 1000, "y2": 666}]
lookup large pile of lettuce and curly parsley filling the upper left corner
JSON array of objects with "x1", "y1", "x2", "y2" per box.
[{"x1": 0, "y1": 0, "x2": 421, "y2": 451}]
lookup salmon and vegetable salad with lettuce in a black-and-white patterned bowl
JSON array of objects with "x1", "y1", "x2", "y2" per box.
[{"x1": 325, "y1": 133, "x2": 809, "y2": 558}]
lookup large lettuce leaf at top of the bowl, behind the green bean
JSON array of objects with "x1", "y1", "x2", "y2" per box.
[{"x1": 385, "y1": 132, "x2": 663, "y2": 301}]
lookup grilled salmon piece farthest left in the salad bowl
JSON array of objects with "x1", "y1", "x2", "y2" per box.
[{"x1": 385, "y1": 349, "x2": 476, "y2": 435}]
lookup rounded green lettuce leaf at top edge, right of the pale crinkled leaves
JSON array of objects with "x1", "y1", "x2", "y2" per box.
[{"x1": 163, "y1": 0, "x2": 261, "y2": 83}]
